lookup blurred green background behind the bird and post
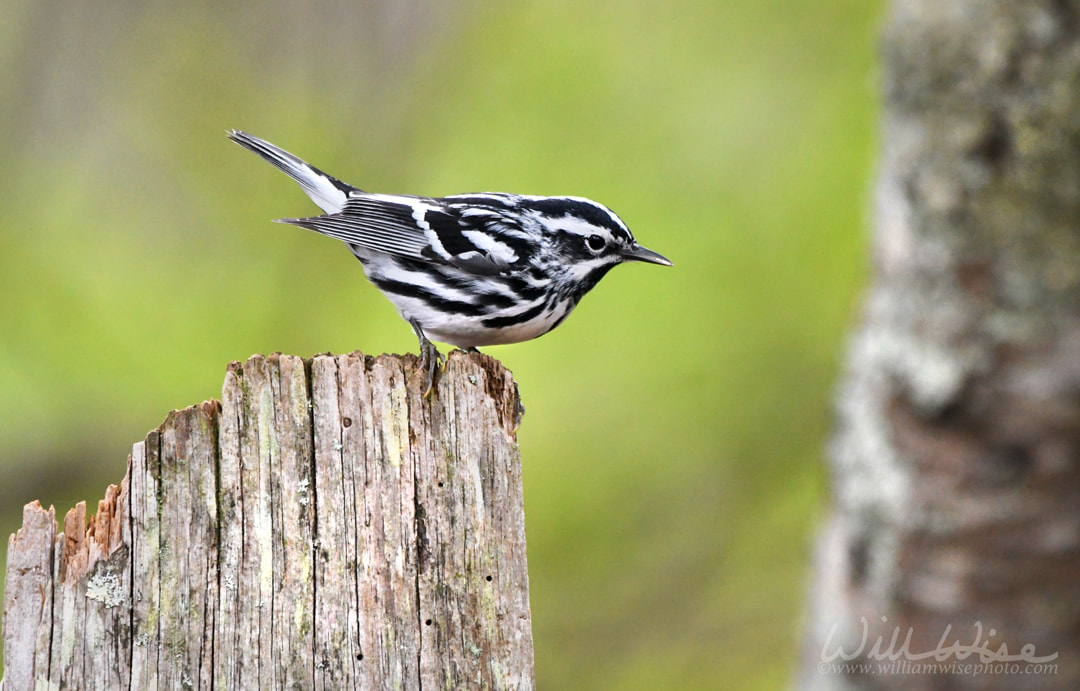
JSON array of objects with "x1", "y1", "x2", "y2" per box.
[{"x1": 0, "y1": 0, "x2": 881, "y2": 689}]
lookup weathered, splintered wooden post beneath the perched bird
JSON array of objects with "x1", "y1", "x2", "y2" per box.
[{"x1": 3, "y1": 352, "x2": 534, "y2": 691}]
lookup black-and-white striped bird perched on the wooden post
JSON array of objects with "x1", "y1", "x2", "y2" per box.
[{"x1": 227, "y1": 130, "x2": 673, "y2": 388}]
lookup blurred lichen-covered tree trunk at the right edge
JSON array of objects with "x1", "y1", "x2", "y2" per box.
[{"x1": 800, "y1": 0, "x2": 1080, "y2": 689}]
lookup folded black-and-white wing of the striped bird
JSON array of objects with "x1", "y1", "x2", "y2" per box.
[{"x1": 281, "y1": 191, "x2": 527, "y2": 274}]
